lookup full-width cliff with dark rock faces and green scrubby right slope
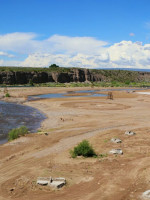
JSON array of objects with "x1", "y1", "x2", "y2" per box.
[{"x1": 0, "y1": 68, "x2": 150, "y2": 85}]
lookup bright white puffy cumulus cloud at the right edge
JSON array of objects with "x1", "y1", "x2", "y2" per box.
[{"x1": 108, "y1": 41, "x2": 150, "y2": 68}]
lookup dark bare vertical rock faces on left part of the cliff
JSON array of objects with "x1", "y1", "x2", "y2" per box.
[{"x1": 0, "y1": 69, "x2": 89, "y2": 85}]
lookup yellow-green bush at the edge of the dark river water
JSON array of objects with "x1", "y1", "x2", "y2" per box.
[{"x1": 8, "y1": 126, "x2": 28, "y2": 141}]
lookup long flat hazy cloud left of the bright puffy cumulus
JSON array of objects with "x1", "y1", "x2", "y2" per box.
[{"x1": 0, "y1": 33, "x2": 108, "y2": 54}]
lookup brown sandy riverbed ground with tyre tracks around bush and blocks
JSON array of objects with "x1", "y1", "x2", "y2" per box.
[{"x1": 0, "y1": 88, "x2": 150, "y2": 200}]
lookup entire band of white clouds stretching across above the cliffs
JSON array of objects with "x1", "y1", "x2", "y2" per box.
[{"x1": 0, "y1": 33, "x2": 150, "y2": 68}]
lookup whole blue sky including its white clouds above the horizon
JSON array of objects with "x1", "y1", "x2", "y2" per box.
[{"x1": 0, "y1": 0, "x2": 150, "y2": 69}]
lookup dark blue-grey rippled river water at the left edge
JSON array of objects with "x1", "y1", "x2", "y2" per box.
[{"x1": 0, "y1": 101, "x2": 46, "y2": 144}]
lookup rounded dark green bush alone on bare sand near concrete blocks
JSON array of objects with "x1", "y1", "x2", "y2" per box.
[{"x1": 70, "y1": 140, "x2": 96, "y2": 158}]
